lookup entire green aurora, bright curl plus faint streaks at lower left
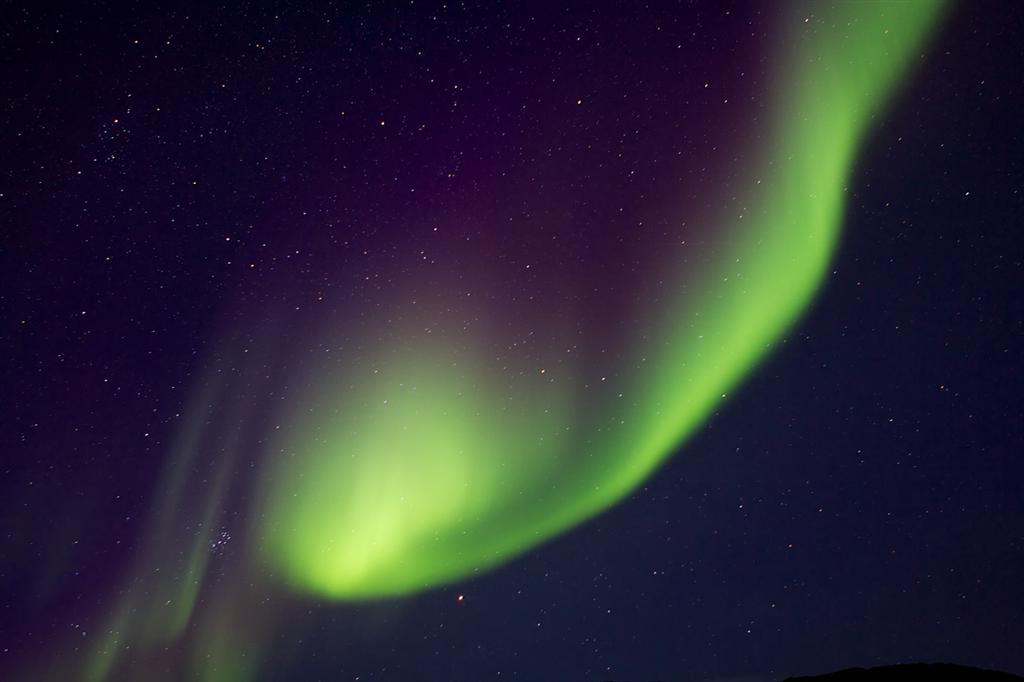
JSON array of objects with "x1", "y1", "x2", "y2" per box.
[{"x1": 44, "y1": 1, "x2": 945, "y2": 682}]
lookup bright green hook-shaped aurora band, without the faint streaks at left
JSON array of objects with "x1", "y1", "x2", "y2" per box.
[{"x1": 253, "y1": 2, "x2": 942, "y2": 599}]
